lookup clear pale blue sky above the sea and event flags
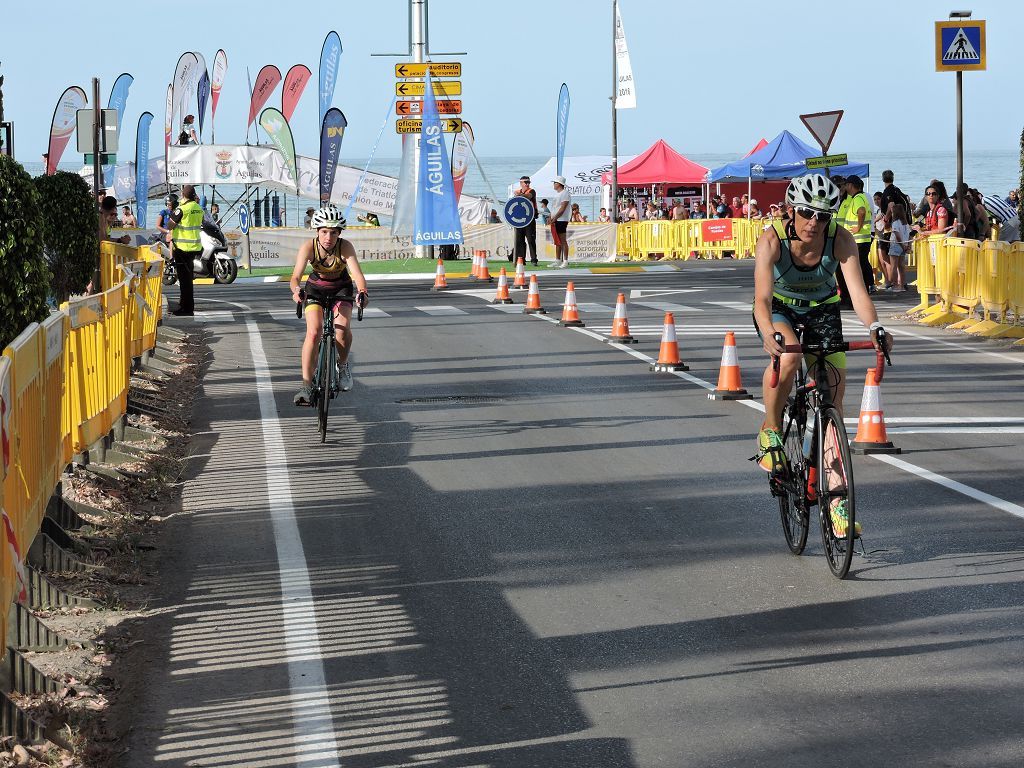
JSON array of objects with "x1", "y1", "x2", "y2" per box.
[{"x1": 0, "y1": 0, "x2": 1024, "y2": 161}]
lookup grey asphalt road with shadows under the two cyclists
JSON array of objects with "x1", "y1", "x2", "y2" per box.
[{"x1": 125, "y1": 261, "x2": 1024, "y2": 768}]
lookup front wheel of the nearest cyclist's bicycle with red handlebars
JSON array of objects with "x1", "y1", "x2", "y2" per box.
[{"x1": 817, "y1": 406, "x2": 857, "y2": 579}]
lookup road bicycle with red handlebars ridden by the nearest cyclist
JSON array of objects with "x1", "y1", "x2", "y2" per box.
[{"x1": 769, "y1": 328, "x2": 892, "y2": 579}]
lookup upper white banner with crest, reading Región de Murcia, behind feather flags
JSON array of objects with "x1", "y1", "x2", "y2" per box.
[{"x1": 167, "y1": 144, "x2": 492, "y2": 224}]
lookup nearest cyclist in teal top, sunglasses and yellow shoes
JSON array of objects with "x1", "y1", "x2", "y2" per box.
[{"x1": 754, "y1": 173, "x2": 892, "y2": 534}]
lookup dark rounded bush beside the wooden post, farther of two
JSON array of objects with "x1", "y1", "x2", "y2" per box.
[{"x1": 36, "y1": 171, "x2": 99, "y2": 304}]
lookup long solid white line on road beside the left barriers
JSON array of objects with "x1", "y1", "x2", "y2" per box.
[{"x1": 237, "y1": 305, "x2": 339, "y2": 768}]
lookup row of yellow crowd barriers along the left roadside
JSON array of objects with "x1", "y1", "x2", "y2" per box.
[{"x1": 0, "y1": 244, "x2": 163, "y2": 651}]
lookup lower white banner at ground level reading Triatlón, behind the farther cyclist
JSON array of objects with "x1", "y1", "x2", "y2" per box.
[{"x1": 239, "y1": 223, "x2": 615, "y2": 268}]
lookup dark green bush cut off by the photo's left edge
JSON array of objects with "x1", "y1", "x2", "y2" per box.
[{"x1": 0, "y1": 155, "x2": 50, "y2": 348}]
